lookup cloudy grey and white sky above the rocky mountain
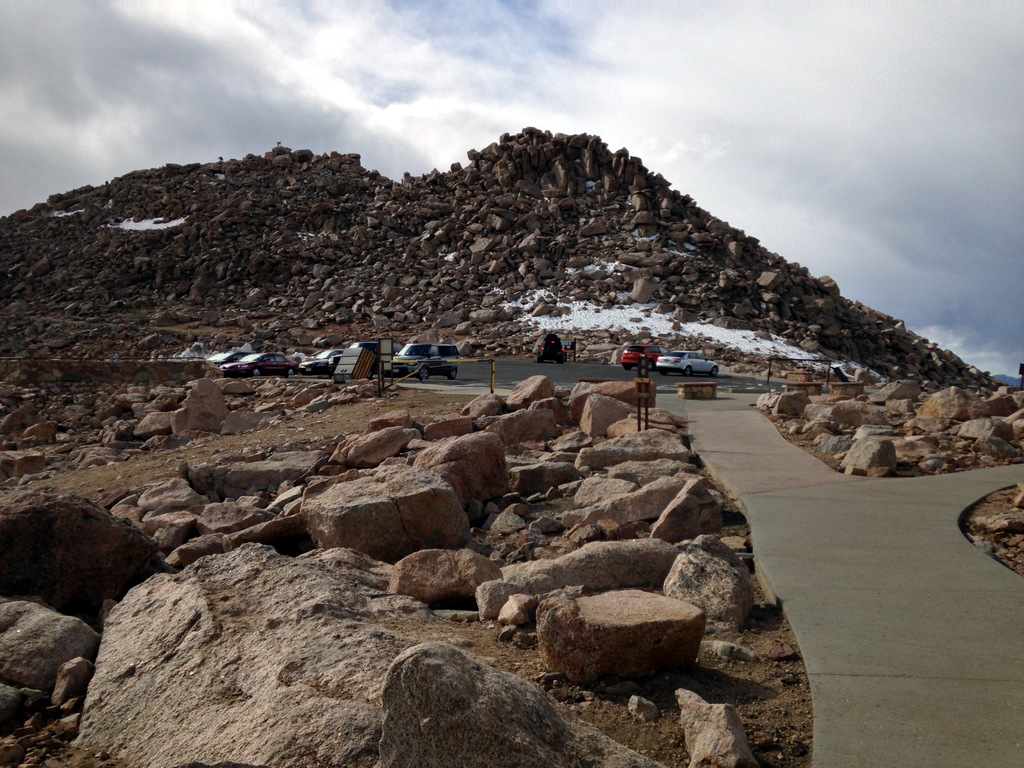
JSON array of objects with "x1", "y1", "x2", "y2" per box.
[{"x1": 0, "y1": 0, "x2": 1024, "y2": 375}]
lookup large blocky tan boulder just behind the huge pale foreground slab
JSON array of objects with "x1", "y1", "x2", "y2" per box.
[{"x1": 302, "y1": 466, "x2": 469, "y2": 562}]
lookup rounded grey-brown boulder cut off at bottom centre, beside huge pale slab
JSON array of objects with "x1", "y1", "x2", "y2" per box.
[{"x1": 378, "y1": 643, "x2": 660, "y2": 768}]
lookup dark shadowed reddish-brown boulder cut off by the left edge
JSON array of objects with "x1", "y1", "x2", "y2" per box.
[{"x1": 0, "y1": 490, "x2": 157, "y2": 612}]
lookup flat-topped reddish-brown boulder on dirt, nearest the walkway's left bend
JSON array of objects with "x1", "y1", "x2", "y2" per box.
[{"x1": 537, "y1": 590, "x2": 705, "y2": 683}]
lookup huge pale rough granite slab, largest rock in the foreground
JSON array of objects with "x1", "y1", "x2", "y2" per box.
[{"x1": 79, "y1": 545, "x2": 430, "y2": 768}]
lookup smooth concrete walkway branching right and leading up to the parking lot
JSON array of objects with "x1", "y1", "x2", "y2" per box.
[{"x1": 658, "y1": 392, "x2": 1024, "y2": 768}]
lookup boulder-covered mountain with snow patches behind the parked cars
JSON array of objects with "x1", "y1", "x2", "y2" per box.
[{"x1": 0, "y1": 128, "x2": 993, "y2": 386}]
